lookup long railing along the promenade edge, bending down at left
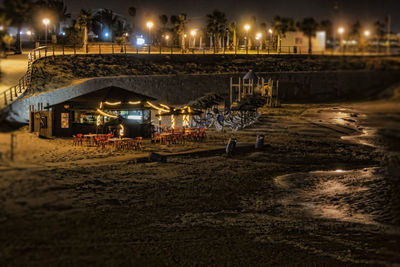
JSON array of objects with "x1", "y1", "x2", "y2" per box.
[{"x1": 0, "y1": 43, "x2": 399, "y2": 109}]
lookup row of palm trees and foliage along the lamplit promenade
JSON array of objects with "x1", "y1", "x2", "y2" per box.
[{"x1": 0, "y1": 0, "x2": 394, "y2": 53}]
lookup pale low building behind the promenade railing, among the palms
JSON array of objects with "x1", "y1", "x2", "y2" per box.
[{"x1": 281, "y1": 31, "x2": 326, "y2": 53}]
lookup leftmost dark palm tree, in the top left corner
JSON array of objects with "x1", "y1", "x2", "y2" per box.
[{"x1": 3, "y1": 0, "x2": 33, "y2": 53}]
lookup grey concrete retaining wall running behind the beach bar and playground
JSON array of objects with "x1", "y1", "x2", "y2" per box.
[{"x1": 8, "y1": 71, "x2": 400, "y2": 123}]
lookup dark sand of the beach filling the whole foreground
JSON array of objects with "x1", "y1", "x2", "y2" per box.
[{"x1": 0, "y1": 102, "x2": 400, "y2": 266}]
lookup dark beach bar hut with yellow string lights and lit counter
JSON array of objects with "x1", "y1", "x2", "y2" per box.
[{"x1": 30, "y1": 86, "x2": 155, "y2": 138}]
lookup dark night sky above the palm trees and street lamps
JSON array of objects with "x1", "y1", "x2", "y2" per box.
[{"x1": 0, "y1": 0, "x2": 400, "y2": 32}]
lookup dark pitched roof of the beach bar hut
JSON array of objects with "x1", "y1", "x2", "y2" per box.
[{"x1": 46, "y1": 86, "x2": 155, "y2": 110}]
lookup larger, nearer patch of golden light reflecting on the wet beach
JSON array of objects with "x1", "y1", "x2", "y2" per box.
[{"x1": 274, "y1": 168, "x2": 377, "y2": 224}]
